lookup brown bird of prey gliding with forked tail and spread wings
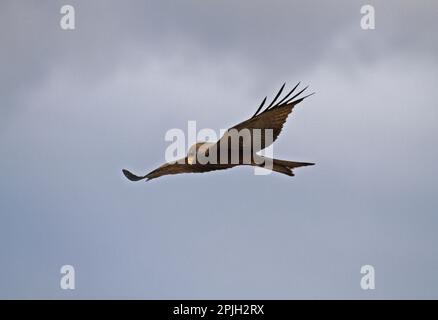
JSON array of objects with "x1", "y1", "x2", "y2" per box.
[{"x1": 122, "y1": 83, "x2": 314, "y2": 181}]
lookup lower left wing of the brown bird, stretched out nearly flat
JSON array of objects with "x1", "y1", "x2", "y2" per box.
[{"x1": 122, "y1": 158, "x2": 234, "y2": 181}]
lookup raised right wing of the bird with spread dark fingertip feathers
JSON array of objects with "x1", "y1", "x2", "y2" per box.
[{"x1": 218, "y1": 83, "x2": 314, "y2": 152}]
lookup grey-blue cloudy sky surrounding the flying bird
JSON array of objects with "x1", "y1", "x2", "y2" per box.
[{"x1": 0, "y1": 0, "x2": 438, "y2": 299}]
